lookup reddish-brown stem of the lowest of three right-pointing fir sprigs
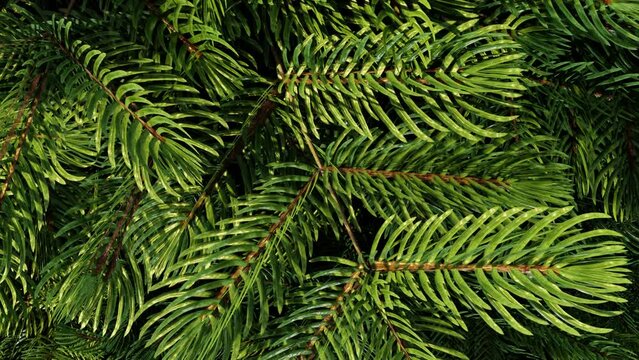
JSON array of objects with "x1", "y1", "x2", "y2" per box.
[{"x1": 371, "y1": 261, "x2": 559, "y2": 273}]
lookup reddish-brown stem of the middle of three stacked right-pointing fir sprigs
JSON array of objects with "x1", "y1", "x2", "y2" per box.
[{"x1": 322, "y1": 166, "x2": 510, "y2": 186}]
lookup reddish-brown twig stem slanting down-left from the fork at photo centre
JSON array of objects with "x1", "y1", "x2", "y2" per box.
[{"x1": 206, "y1": 172, "x2": 318, "y2": 311}]
